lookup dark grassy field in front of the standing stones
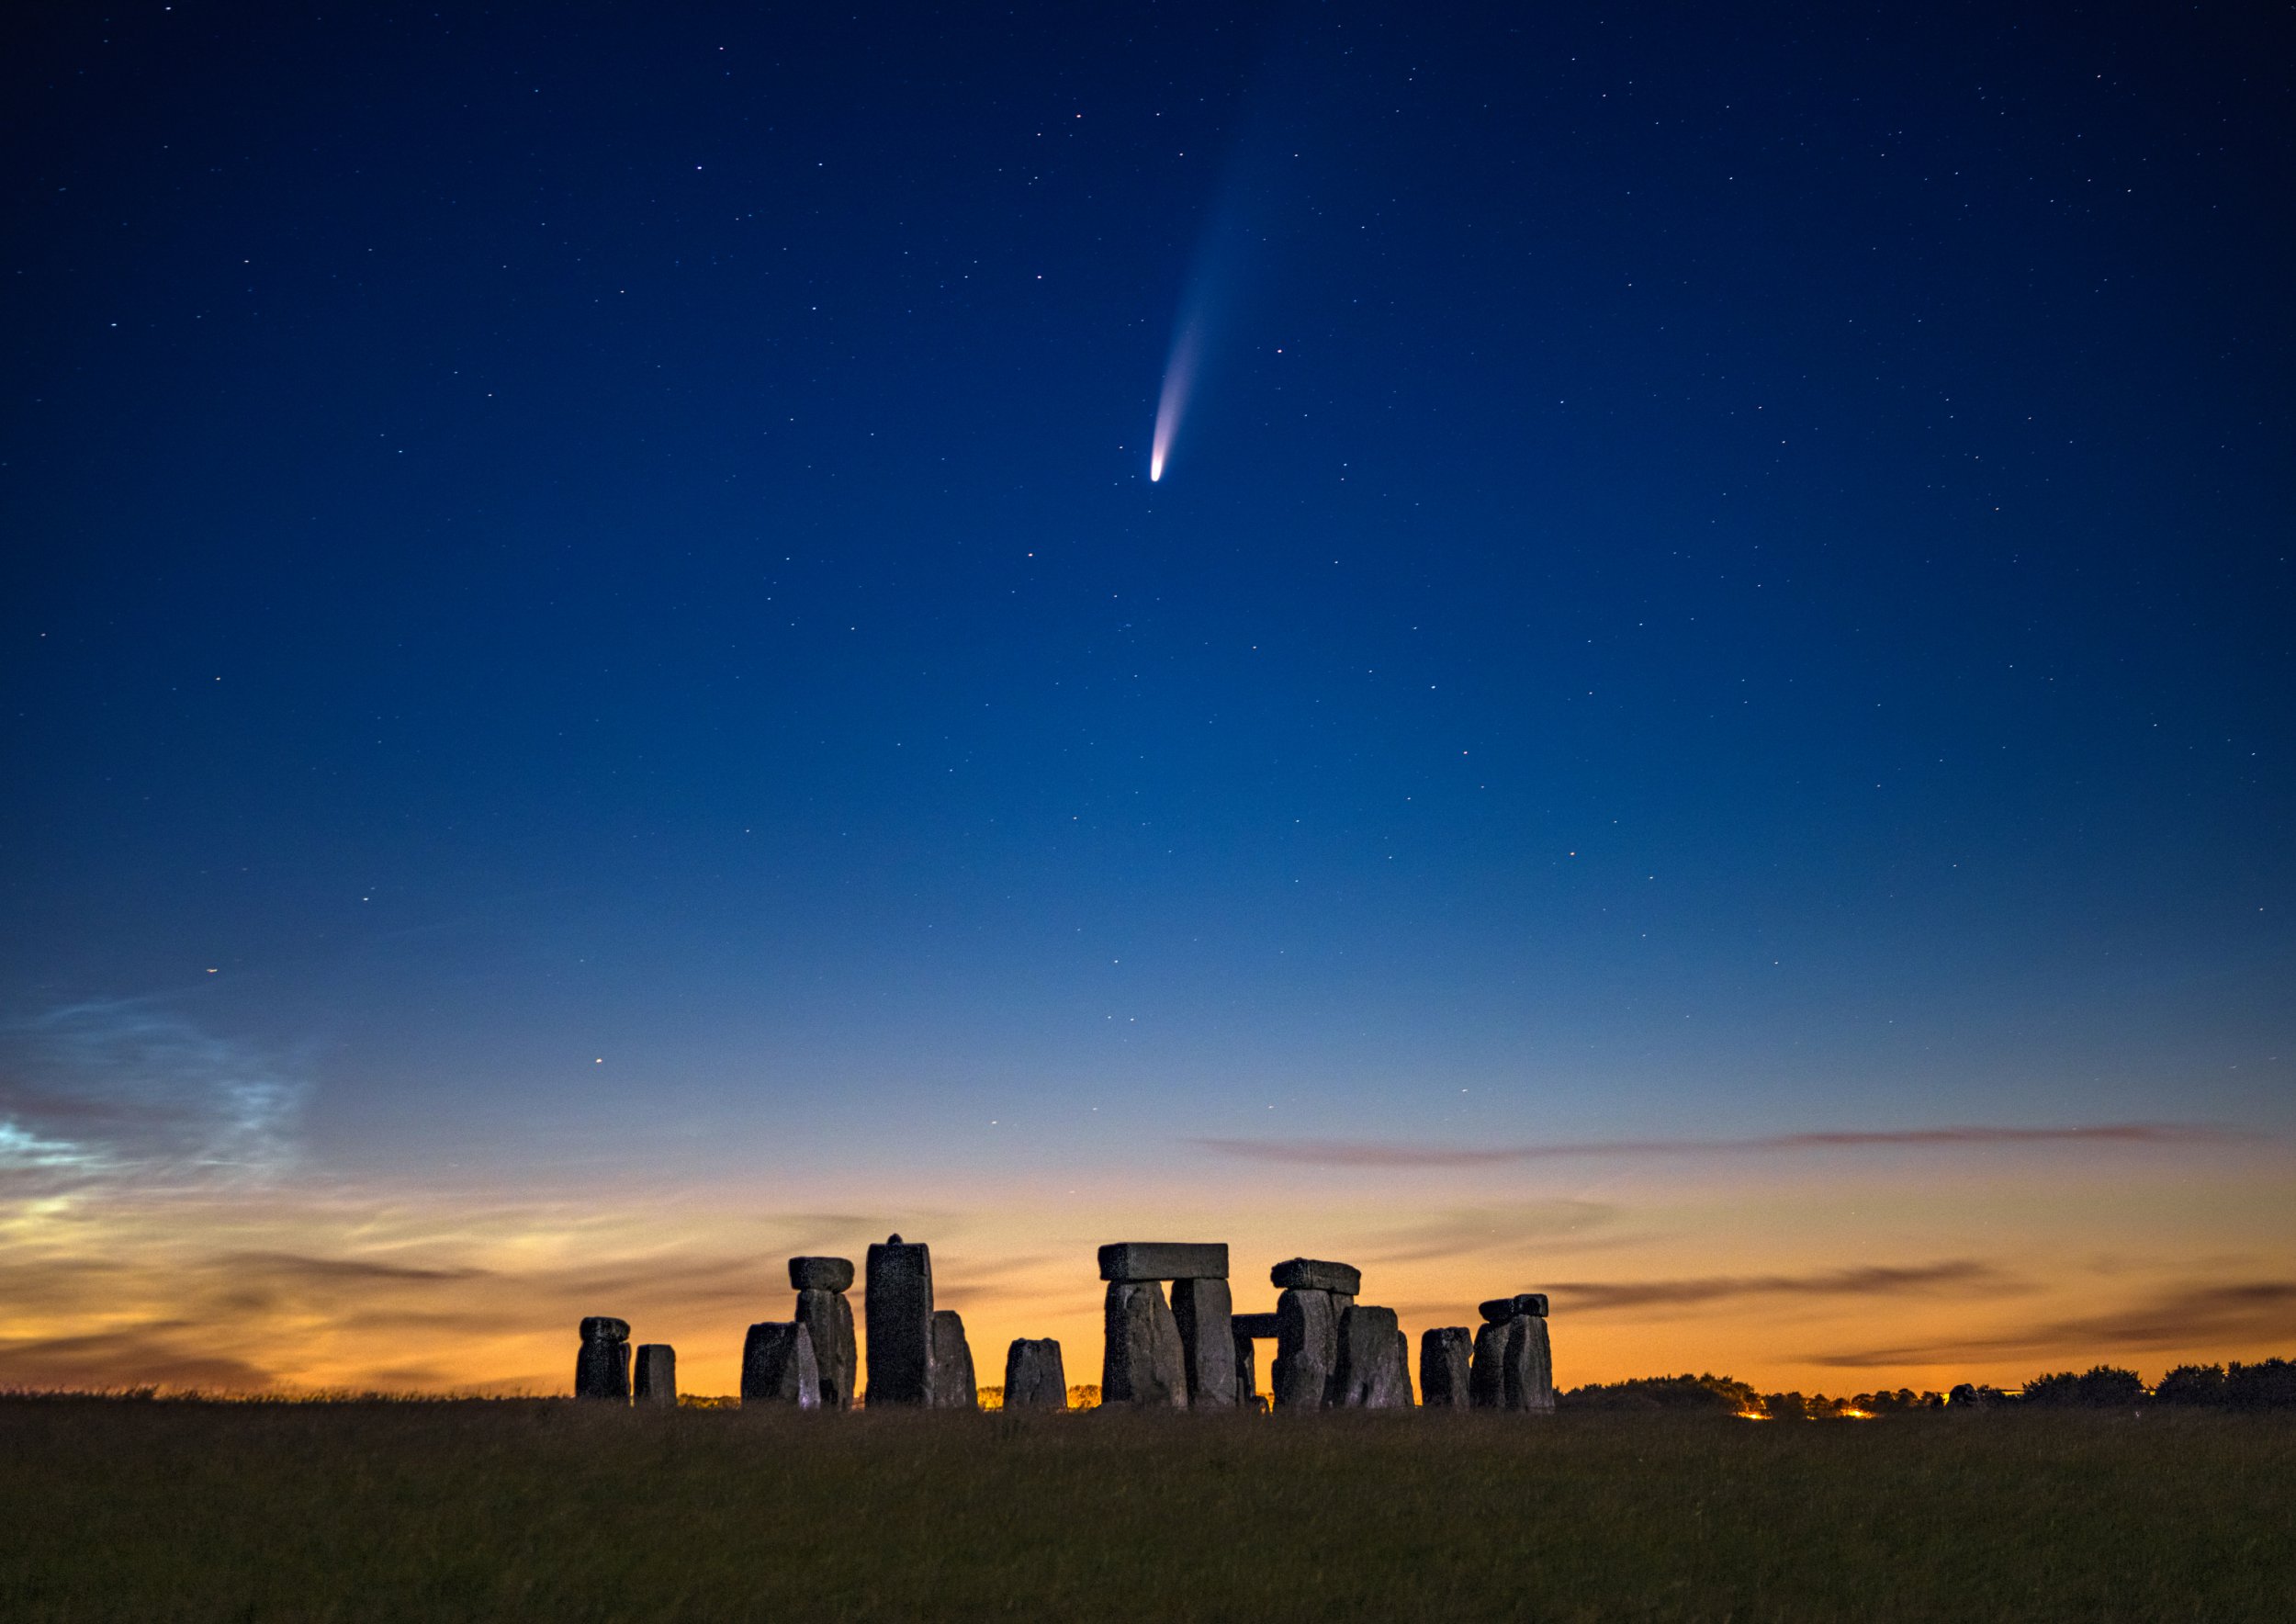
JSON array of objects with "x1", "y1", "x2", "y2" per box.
[{"x1": 0, "y1": 1399, "x2": 2296, "y2": 1624}]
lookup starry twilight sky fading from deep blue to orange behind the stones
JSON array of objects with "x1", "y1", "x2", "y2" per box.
[{"x1": 0, "y1": 0, "x2": 2296, "y2": 1392}]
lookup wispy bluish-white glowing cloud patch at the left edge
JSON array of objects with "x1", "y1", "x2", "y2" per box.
[{"x1": 0, "y1": 999, "x2": 310, "y2": 1199}]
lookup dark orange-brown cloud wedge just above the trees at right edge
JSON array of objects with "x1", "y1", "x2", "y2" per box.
[{"x1": 1807, "y1": 1280, "x2": 2296, "y2": 1369}]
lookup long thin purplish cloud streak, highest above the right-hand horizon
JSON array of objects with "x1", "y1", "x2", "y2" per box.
[{"x1": 1189, "y1": 1123, "x2": 2232, "y2": 1167}]
